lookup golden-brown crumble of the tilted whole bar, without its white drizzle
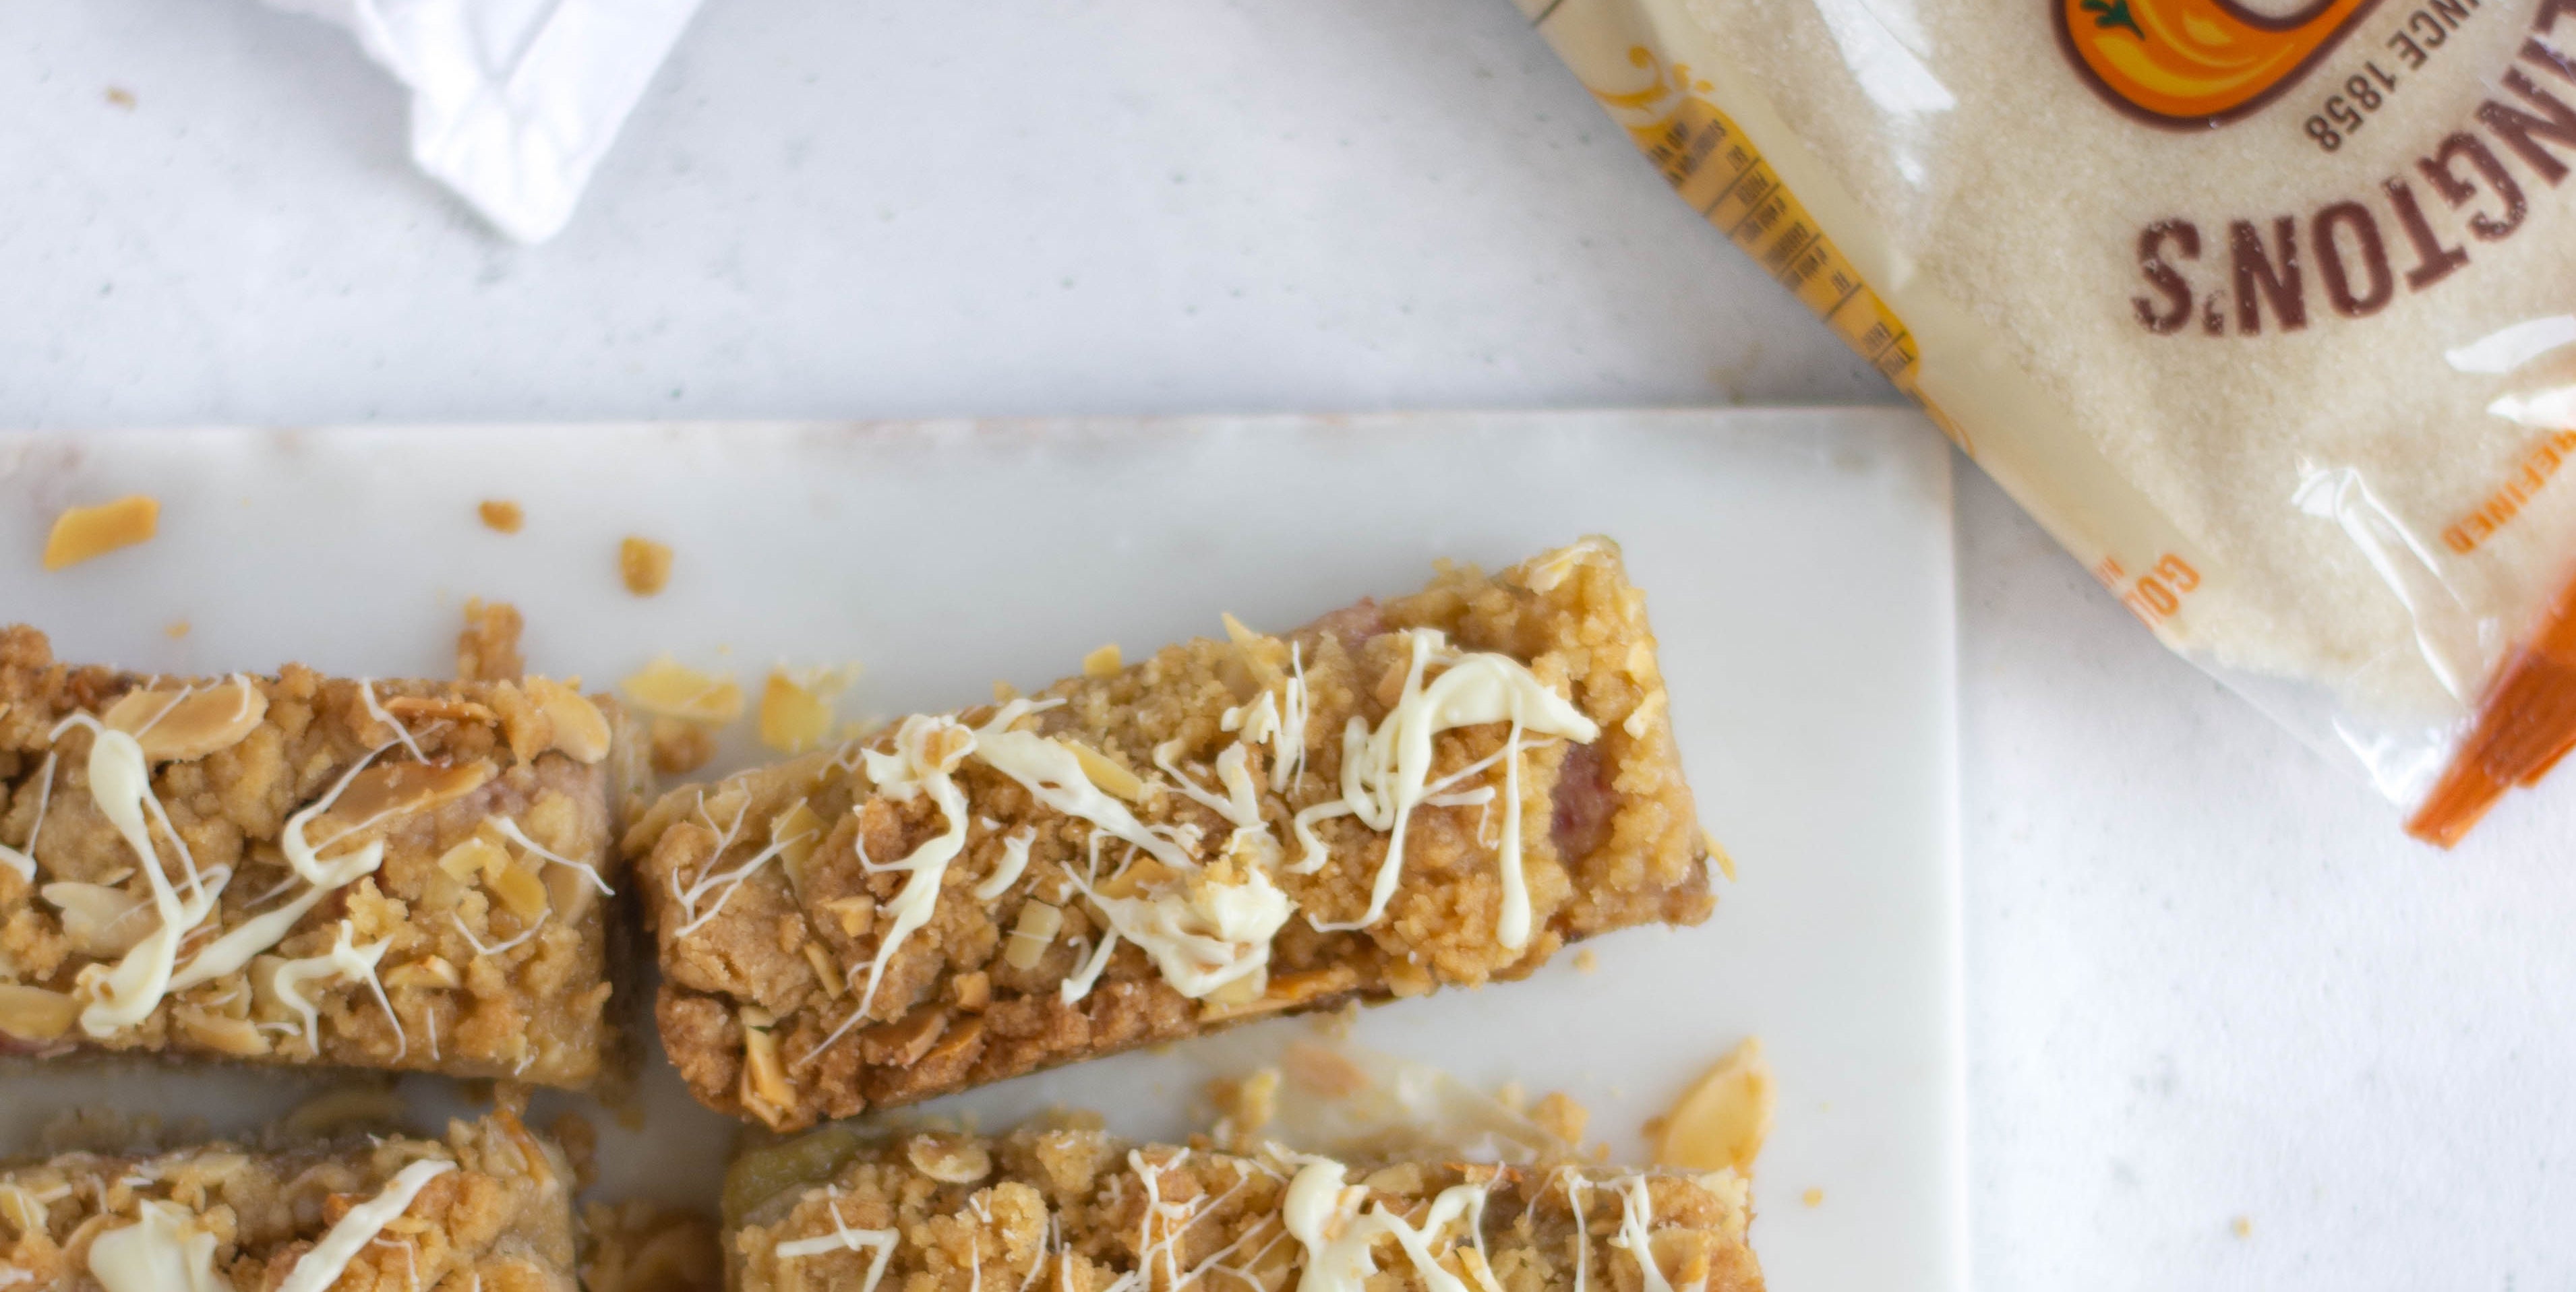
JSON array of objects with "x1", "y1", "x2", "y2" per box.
[{"x1": 626, "y1": 541, "x2": 1710, "y2": 1128}]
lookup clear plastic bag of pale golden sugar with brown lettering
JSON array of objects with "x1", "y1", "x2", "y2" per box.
[{"x1": 1520, "y1": 0, "x2": 2576, "y2": 844}]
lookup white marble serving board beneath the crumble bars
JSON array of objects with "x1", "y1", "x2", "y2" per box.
[{"x1": 0, "y1": 409, "x2": 1965, "y2": 1292}]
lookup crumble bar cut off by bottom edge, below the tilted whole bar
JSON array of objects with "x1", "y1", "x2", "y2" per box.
[{"x1": 727, "y1": 1128, "x2": 1762, "y2": 1292}]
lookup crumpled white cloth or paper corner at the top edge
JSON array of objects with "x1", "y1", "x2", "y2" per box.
[{"x1": 268, "y1": 0, "x2": 698, "y2": 242}]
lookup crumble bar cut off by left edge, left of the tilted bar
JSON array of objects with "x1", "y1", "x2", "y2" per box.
[{"x1": 0, "y1": 628, "x2": 634, "y2": 1088}]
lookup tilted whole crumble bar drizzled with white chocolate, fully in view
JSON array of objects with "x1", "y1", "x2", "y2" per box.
[{"x1": 626, "y1": 538, "x2": 1710, "y2": 1130}]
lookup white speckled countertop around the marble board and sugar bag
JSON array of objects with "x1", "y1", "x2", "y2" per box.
[{"x1": 0, "y1": 0, "x2": 2576, "y2": 1292}]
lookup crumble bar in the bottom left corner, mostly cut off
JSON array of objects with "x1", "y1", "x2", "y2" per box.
[{"x1": 0, "y1": 1112, "x2": 577, "y2": 1292}]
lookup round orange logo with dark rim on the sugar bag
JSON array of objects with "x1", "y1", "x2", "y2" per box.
[{"x1": 2056, "y1": 0, "x2": 2380, "y2": 129}]
